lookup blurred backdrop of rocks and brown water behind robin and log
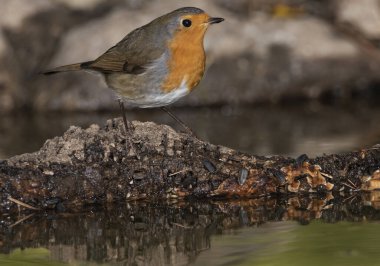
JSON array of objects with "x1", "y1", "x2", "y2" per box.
[{"x1": 0, "y1": 0, "x2": 380, "y2": 159}]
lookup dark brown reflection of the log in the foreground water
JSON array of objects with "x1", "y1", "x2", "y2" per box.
[{"x1": 0, "y1": 194, "x2": 380, "y2": 265}]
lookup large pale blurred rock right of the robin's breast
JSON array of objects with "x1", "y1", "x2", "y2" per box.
[{"x1": 185, "y1": 17, "x2": 377, "y2": 105}]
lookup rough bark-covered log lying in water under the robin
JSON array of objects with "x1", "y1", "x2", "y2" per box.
[{"x1": 0, "y1": 119, "x2": 380, "y2": 212}]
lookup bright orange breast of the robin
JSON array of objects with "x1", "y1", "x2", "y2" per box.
[{"x1": 162, "y1": 16, "x2": 206, "y2": 92}]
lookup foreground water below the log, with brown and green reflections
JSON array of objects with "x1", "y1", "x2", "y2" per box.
[{"x1": 0, "y1": 192, "x2": 380, "y2": 265}]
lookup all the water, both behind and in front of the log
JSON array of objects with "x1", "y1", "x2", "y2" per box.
[{"x1": 0, "y1": 104, "x2": 380, "y2": 266}]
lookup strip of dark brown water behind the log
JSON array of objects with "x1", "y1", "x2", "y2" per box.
[{"x1": 0, "y1": 105, "x2": 380, "y2": 159}]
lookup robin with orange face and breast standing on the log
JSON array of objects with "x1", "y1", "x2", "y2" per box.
[{"x1": 44, "y1": 7, "x2": 224, "y2": 137}]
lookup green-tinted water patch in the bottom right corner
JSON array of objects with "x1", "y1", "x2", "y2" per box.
[{"x1": 194, "y1": 221, "x2": 380, "y2": 266}]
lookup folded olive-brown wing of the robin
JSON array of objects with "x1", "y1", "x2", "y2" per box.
[{"x1": 81, "y1": 24, "x2": 165, "y2": 74}]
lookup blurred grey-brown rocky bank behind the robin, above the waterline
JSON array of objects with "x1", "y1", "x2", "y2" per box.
[{"x1": 0, "y1": 0, "x2": 379, "y2": 112}]
